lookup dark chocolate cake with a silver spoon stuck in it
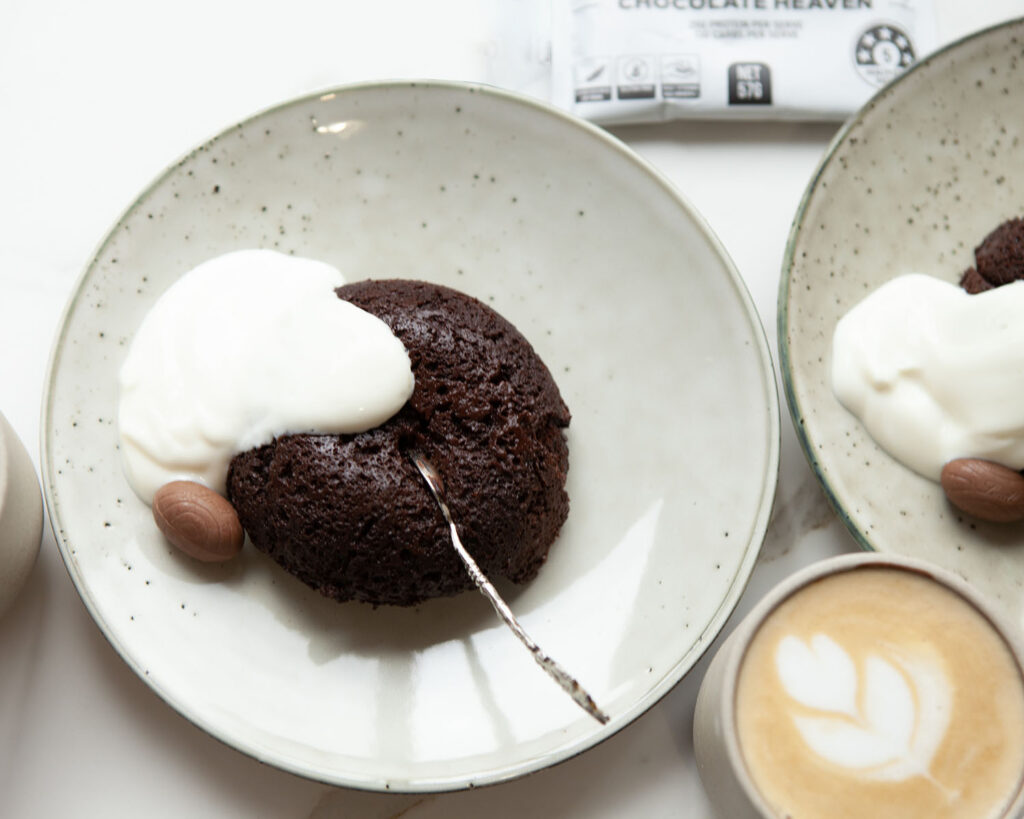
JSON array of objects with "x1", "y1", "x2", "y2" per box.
[{"x1": 227, "y1": 279, "x2": 569, "y2": 606}]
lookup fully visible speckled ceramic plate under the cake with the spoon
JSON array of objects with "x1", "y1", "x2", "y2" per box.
[{"x1": 43, "y1": 83, "x2": 778, "y2": 791}]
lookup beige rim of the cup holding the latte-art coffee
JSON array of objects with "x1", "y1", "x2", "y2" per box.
[{"x1": 718, "y1": 552, "x2": 1024, "y2": 819}]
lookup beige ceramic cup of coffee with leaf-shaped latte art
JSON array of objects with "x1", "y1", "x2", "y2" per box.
[{"x1": 693, "y1": 554, "x2": 1024, "y2": 819}]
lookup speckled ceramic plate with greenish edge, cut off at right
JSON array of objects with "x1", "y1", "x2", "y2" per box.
[{"x1": 778, "y1": 20, "x2": 1024, "y2": 624}]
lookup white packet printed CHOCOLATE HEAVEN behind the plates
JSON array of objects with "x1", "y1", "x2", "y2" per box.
[{"x1": 551, "y1": 0, "x2": 936, "y2": 124}]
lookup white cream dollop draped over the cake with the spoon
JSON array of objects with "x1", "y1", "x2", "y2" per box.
[{"x1": 118, "y1": 250, "x2": 413, "y2": 503}]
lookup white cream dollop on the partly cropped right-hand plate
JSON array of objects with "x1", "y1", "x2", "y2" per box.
[{"x1": 831, "y1": 273, "x2": 1024, "y2": 481}]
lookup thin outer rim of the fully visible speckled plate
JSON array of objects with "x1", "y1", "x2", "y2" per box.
[{"x1": 39, "y1": 80, "x2": 781, "y2": 793}]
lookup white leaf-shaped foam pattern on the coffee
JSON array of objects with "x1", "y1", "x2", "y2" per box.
[{"x1": 775, "y1": 634, "x2": 952, "y2": 787}]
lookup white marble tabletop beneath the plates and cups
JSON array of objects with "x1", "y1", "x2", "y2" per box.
[{"x1": 0, "y1": 0, "x2": 1024, "y2": 819}]
